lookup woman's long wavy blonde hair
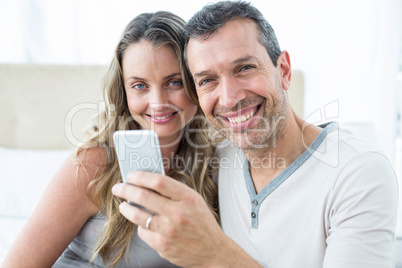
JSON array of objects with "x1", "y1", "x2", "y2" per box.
[{"x1": 76, "y1": 11, "x2": 219, "y2": 267}]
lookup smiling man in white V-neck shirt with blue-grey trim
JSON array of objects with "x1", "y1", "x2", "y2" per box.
[{"x1": 111, "y1": 1, "x2": 398, "y2": 267}]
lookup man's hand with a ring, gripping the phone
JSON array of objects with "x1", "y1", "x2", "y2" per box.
[{"x1": 113, "y1": 172, "x2": 229, "y2": 267}]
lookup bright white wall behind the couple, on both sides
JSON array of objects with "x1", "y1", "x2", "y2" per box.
[{"x1": 0, "y1": 0, "x2": 402, "y2": 160}]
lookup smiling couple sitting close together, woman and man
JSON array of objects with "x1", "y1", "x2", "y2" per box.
[{"x1": 3, "y1": 1, "x2": 398, "y2": 268}]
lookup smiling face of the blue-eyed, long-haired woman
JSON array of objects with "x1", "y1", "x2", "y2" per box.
[{"x1": 122, "y1": 40, "x2": 197, "y2": 144}]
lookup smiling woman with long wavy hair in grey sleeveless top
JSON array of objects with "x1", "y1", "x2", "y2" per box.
[{"x1": 3, "y1": 12, "x2": 218, "y2": 267}]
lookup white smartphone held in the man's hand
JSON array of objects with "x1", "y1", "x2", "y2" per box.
[{"x1": 113, "y1": 130, "x2": 165, "y2": 214}]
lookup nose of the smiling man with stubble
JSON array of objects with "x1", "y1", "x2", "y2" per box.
[{"x1": 219, "y1": 76, "x2": 246, "y2": 109}]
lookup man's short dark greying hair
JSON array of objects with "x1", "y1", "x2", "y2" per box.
[{"x1": 184, "y1": 1, "x2": 281, "y2": 66}]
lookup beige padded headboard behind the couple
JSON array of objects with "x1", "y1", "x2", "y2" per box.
[{"x1": 0, "y1": 64, "x2": 304, "y2": 150}]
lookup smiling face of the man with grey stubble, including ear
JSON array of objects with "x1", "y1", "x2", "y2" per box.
[{"x1": 187, "y1": 19, "x2": 290, "y2": 150}]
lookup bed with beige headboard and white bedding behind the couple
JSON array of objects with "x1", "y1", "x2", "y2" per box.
[{"x1": 0, "y1": 64, "x2": 304, "y2": 265}]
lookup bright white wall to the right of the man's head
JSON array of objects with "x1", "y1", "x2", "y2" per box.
[{"x1": 256, "y1": 0, "x2": 402, "y2": 163}]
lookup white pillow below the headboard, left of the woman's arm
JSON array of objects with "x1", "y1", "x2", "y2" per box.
[{"x1": 0, "y1": 147, "x2": 72, "y2": 218}]
